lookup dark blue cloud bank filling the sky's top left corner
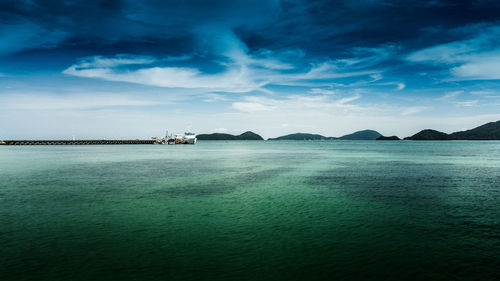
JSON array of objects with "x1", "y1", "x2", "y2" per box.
[{"x1": 0, "y1": 0, "x2": 279, "y2": 52}]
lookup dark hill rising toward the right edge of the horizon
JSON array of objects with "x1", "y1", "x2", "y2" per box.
[{"x1": 405, "y1": 121, "x2": 500, "y2": 140}]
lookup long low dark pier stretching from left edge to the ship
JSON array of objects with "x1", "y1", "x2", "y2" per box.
[{"x1": 0, "y1": 140, "x2": 155, "y2": 145}]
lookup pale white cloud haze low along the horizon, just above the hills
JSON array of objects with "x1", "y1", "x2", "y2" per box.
[{"x1": 0, "y1": 89, "x2": 500, "y2": 138}]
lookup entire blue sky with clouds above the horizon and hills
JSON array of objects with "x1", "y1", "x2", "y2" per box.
[{"x1": 0, "y1": 0, "x2": 500, "y2": 139}]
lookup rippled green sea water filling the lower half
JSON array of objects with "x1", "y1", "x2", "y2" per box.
[{"x1": 0, "y1": 141, "x2": 500, "y2": 281}]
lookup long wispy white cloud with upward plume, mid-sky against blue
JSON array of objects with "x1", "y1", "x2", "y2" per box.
[{"x1": 63, "y1": 29, "x2": 390, "y2": 93}]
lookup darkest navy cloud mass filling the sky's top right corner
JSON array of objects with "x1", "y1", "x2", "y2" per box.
[{"x1": 237, "y1": 0, "x2": 500, "y2": 55}]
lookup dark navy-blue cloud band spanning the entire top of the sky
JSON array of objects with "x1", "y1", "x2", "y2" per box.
[{"x1": 0, "y1": 0, "x2": 500, "y2": 67}]
